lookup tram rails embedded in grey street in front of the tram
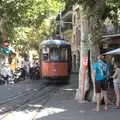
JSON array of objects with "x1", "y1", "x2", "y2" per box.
[{"x1": 0, "y1": 83, "x2": 59, "y2": 120}]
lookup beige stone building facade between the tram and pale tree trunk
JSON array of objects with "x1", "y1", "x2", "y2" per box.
[{"x1": 62, "y1": 5, "x2": 80, "y2": 72}]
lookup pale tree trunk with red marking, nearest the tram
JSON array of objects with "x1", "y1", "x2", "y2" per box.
[{"x1": 76, "y1": 6, "x2": 88, "y2": 101}]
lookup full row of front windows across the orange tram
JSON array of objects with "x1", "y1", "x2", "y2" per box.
[{"x1": 42, "y1": 47, "x2": 68, "y2": 61}]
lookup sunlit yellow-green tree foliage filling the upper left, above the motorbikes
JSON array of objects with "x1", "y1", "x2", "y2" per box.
[{"x1": 0, "y1": 0, "x2": 62, "y2": 54}]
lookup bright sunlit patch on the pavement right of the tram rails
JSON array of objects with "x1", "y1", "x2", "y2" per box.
[{"x1": 36, "y1": 107, "x2": 66, "y2": 119}]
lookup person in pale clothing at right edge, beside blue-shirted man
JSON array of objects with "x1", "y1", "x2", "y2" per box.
[{"x1": 112, "y1": 64, "x2": 120, "y2": 109}]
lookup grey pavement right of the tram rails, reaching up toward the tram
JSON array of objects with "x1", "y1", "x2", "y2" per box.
[{"x1": 36, "y1": 74, "x2": 120, "y2": 120}]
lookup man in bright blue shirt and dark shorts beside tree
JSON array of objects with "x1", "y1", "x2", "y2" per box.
[{"x1": 92, "y1": 55, "x2": 109, "y2": 111}]
